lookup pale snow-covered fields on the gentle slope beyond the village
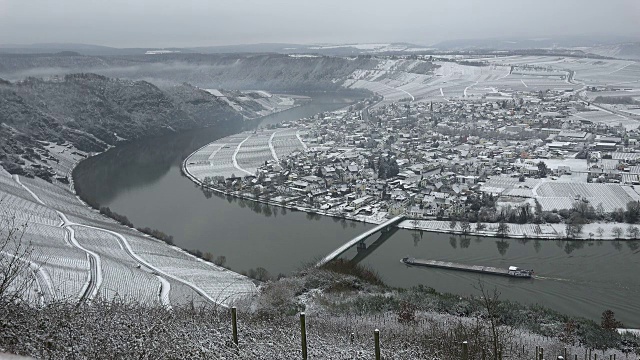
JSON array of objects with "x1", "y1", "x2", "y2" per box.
[{"x1": 344, "y1": 56, "x2": 628, "y2": 103}]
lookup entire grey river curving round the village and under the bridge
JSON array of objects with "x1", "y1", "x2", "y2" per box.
[{"x1": 75, "y1": 95, "x2": 640, "y2": 327}]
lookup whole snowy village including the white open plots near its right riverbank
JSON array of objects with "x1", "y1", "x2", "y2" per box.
[{"x1": 198, "y1": 89, "x2": 640, "y2": 239}]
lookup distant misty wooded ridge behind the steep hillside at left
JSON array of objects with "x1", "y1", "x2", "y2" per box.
[{"x1": 0, "y1": 52, "x2": 378, "y2": 91}]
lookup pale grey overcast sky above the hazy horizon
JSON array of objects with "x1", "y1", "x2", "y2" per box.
[{"x1": 0, "y1": 0, "x2": 640, "y2": 47}]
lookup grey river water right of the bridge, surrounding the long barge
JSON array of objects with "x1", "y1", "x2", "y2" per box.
[{"x1": 352, "y1": 230, "x2": 640, "y2": 326}]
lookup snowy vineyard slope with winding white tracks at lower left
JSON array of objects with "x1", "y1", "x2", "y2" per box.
[{"x1": 0, "y1": 163, "x2": 257, "y2": 306}]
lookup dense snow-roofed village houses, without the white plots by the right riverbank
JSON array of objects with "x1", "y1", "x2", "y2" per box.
[{"x1": 216, "y1": 91, "x2": 640, "y2": 219}]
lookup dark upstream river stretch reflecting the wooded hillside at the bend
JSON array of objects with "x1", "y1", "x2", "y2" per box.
[{"x1": 73, "y1": 92, "x2": 362, "y2": 205}]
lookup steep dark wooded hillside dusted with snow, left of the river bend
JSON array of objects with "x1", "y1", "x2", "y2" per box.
[{"x1": 0, "y1": 74, "x2": 248, "y2": 178}]
